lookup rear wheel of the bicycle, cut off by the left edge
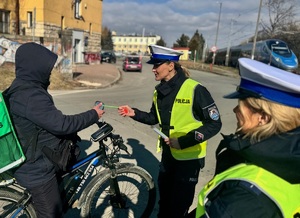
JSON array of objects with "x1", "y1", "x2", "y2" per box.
[{"x1": 0, "y1": 189, "x2": 37, "y2": 218}]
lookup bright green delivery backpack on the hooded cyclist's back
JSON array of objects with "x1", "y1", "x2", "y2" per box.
[{"x1": 0, "y1": 92, "x2": 25, "y2": 173}]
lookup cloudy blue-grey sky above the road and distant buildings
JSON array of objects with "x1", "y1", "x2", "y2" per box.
[{"x1": 103, "y1": 0, "x2": 300, "y2": 48}]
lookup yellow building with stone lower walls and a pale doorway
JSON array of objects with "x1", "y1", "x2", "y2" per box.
[{"x1": 0, "y1": 0, "x2": 102, "y2": 63}]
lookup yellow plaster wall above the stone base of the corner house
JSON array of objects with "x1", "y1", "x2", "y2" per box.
[{"x1": 20, "y1": 0, "x2": 102, "y2": 37}]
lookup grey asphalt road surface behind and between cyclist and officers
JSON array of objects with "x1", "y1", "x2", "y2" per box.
[{"x1": 53, "y1": 58, "x2": 239, "y2": 217}]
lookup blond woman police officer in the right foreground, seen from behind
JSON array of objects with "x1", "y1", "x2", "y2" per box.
[{"x1": 196, "y1": 58, "x2": 300, "y2": 218}]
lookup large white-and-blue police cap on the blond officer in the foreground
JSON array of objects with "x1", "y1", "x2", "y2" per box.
[{"x1": 224, "y1": 58, "x2": 300, "y2": 108}]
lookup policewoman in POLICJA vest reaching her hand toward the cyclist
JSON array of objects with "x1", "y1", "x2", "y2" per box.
[{"x1": 119, "y1": 45, "x2": 222, "y2": 218}]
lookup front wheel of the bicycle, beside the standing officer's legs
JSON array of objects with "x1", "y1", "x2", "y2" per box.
[{"x1": 81, "y1": 166, "x2": 156, "y2": 218}]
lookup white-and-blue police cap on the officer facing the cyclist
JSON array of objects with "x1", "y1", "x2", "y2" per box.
[{"x1": 147, "y1": 45, "x2": 183, "y2": 64}]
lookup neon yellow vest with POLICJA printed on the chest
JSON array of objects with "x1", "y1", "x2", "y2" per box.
[{"x1": 153, "y1": 79, "x2": 207, "y2": 160}]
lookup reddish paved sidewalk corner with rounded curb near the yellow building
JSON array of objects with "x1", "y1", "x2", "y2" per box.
[{"x1": 73, "y1": 63, "x2": 121, "y2": 88}]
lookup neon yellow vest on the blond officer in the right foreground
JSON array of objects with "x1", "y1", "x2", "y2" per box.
[{"x1": 196, "y1": 164, "x2": 300, "y2": 218}]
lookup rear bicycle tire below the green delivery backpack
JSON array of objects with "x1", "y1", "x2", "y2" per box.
[{"x1": 0, "y1": 189, "x2": 37, "y2": 218}]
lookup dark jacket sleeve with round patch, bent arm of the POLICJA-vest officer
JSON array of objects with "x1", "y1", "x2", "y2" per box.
[{"x1": 178, "y1": 85, "x2": 222, "y2": 149}]
